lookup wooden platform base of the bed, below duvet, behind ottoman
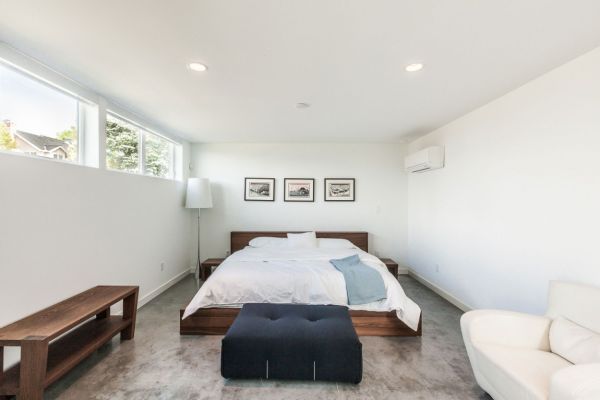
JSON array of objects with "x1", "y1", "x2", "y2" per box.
[{"x1": 179, "y1": 308, "x2": 422, "y2": 336}]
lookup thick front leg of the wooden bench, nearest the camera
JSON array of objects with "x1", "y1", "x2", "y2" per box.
[{"x1": 19, "y1": 336, "x2": 48, "y2": 400}]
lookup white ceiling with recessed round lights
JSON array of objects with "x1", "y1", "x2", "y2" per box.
[{"x1": 0, "y1": 0, "x2": 600, "y2": 142}]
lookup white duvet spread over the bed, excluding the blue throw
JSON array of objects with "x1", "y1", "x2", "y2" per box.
[{"x1": 183, "y1": 247, "x2": 421, "y2": 330}]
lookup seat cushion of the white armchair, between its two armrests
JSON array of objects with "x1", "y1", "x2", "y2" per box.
[{"x1": 474, "y1": 343, "x2": 572, "y2": 400}]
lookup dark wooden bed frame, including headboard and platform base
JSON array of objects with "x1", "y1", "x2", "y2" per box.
[{"x1": 179, "y1": 231, "x2": 423, "y2": 336}]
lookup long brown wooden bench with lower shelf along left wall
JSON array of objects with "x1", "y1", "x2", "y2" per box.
[{"x1": 0, "y1": 286, "x2": 139, "y2": 400}]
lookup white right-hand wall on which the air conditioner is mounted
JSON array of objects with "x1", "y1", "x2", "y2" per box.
[{"x1": 408, "y1": 48, "x2": 600, "y2": 313}]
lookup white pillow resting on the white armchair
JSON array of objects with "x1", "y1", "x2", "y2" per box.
[{"x1": 550, "y1": 317, "x2": 600, "y2": 364}]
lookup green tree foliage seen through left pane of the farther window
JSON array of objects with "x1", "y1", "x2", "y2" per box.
[{"x1": 106, "y1": 120, "x2": 139, "y2": 172}]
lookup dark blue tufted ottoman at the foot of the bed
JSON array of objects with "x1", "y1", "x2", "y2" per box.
[{"x1": 221, "y1": 304, "x2": 362, "y2": 383}]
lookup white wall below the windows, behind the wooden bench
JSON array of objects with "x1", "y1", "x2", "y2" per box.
[{"x1": 0, "y1": 150, "x2": 193, "y2": 365}]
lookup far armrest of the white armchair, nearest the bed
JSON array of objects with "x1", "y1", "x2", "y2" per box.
[{"x1": 460, "y1": 310, "x2": 552, "y2": 351}]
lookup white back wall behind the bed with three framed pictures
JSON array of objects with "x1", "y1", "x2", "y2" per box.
[{"x1": 192, "y1": 143, "x2": 407, "y2": 263}]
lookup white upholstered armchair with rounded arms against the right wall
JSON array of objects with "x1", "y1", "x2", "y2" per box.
[{"x1": 461, "y1": 282, "x2": 600, "y2": 400}]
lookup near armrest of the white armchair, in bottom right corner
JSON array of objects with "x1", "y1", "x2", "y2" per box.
[{"x1": 549, "y1": 363, "x2": 600, "y2": 400}]
